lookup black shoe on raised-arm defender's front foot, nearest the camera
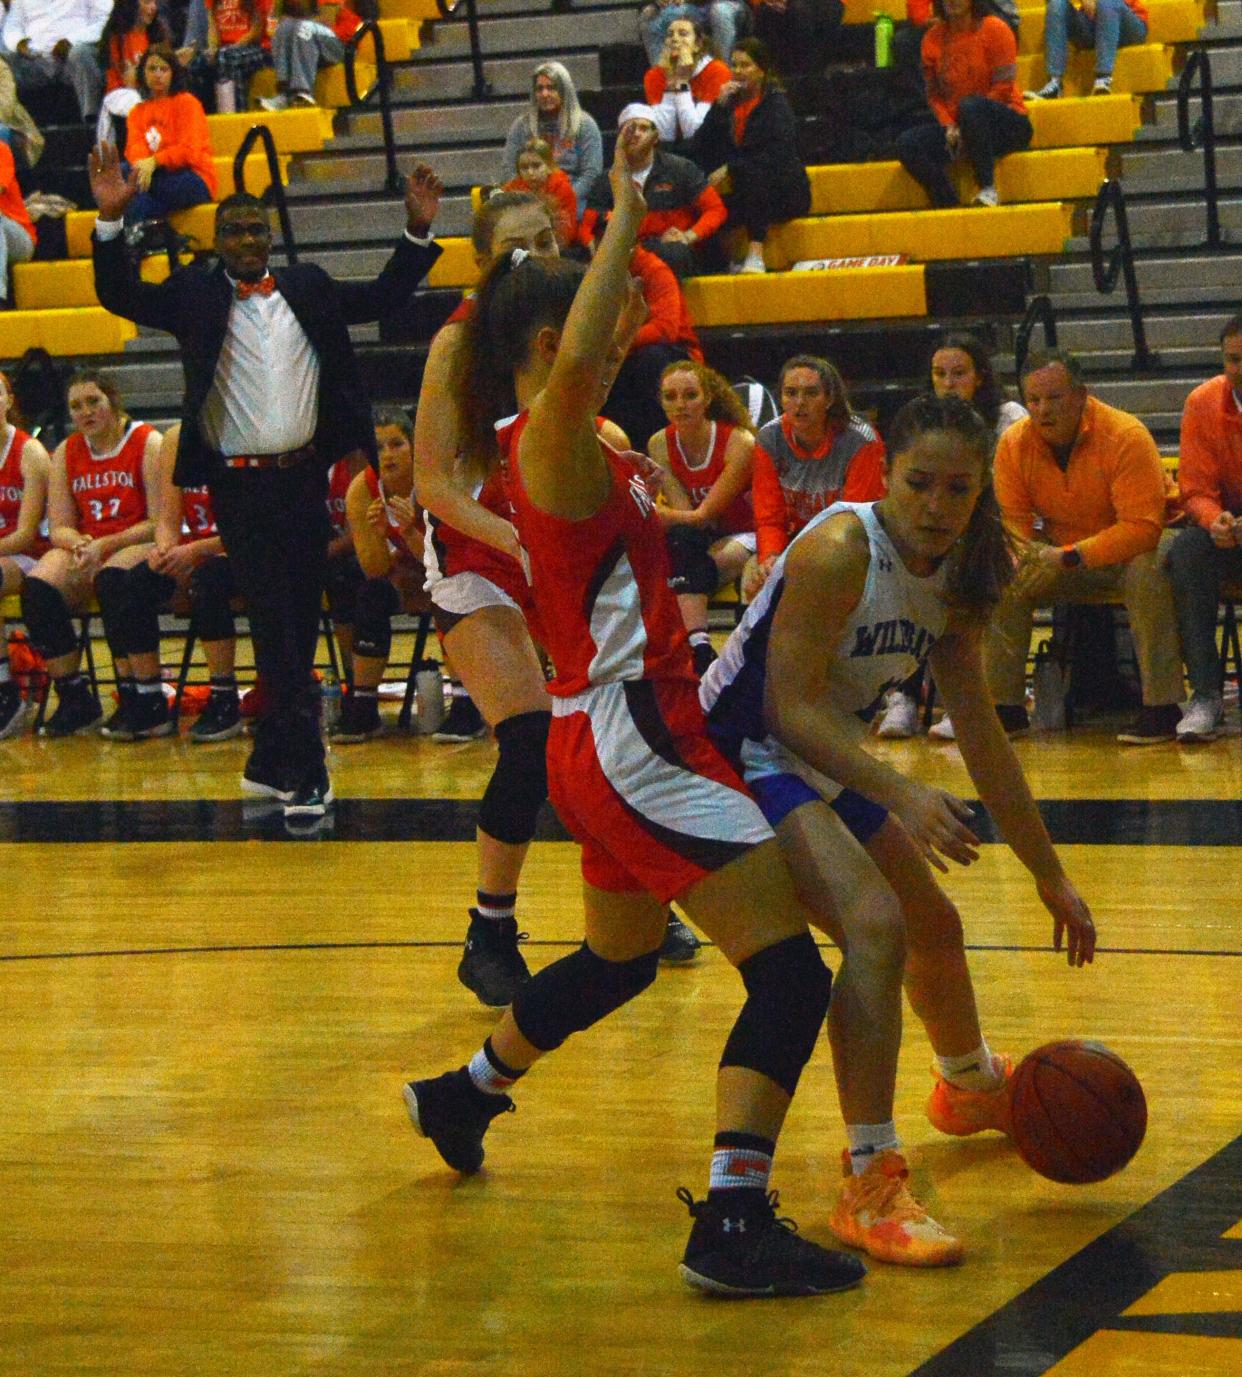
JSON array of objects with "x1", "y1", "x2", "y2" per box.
[{"x1": 677, "y1": 1186, "x2": 867, "y2": 1297}]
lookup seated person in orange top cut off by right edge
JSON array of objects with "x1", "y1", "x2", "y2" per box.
[{"x1": 1168, "y1": 315, "x2": 1242, "y2": 741}]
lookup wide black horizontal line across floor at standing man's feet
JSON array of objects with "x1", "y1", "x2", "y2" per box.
[{"x1": 0, "y1": 799, "x2": 1242, "y2": 847}]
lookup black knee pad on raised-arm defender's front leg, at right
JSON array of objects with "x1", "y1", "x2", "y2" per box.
[{"x1": 720, "y1": 932, "x2": 832, "y2": 1095}]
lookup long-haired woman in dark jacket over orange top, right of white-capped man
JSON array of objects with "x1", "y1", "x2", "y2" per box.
[{"x1": 695, "y1": 39, "x2": 811, "y2": 273}]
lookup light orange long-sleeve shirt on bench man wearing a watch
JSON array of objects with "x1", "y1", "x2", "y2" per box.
[{"x1": 994, "y1": 397, "x2": 1165, "y2": 569}]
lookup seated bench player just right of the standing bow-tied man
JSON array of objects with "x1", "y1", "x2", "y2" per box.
[{"x1": 329, "y1": 406, "x2": 427, "y2": 745}]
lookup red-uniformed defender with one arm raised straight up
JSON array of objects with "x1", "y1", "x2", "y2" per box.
[{"x1": 405, "y1": 131, "x2": 863, "y2": 1296}]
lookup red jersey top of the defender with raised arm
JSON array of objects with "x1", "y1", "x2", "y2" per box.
[{"x1": 497, "y1": 412, "x2": 694, "y2": 697}]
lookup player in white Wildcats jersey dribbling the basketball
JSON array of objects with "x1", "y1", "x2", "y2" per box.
[{"x1": 701, "y1": 398, "x2": 1095, "y2": 1265}]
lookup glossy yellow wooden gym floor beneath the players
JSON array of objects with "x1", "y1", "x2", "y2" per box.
[{"x1": 0, "y1": 663, "x2": 1242, "y2": 1377}]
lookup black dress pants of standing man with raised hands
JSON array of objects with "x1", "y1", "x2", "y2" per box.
[{"x1": 208, "y1": 460, "x2": 330, "y2": 789}]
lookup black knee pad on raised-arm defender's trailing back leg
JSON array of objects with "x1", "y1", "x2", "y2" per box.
[{"x1": 512, "y1": 942, "x2": 660, "y2": 1052}]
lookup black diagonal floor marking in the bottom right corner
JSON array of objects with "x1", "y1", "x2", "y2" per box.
[{"x1": 910, "y1": 1137, "x2": 1242, "y2": 1377}]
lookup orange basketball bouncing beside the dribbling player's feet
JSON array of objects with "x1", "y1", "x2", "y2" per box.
[{"x1": 1011, "y1": 1041, "x2": 1147, "y2": 1186}]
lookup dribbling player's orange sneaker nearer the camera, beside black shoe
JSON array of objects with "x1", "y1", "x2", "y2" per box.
[{"x1": 828, "y1": 1150, "x2": 965, "y2": 1267}]
